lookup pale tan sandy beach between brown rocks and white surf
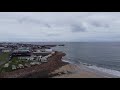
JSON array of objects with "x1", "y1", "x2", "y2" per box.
[{"x1": 52, "y1": 64, "x2": 117, "y2": 78}]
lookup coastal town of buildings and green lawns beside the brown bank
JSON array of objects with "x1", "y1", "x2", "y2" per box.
[{"x1": 0, "y1": 43, "x2": 67, "y2": 77}]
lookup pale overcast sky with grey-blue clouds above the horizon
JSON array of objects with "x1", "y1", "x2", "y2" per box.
[{"x1": 0, "y1": 12, "x2": 120, "y2": 42}]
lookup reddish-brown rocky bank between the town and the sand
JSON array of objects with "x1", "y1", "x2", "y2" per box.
[{"x1": 0, "y1": 52, "x2": 68, "y2": 78}]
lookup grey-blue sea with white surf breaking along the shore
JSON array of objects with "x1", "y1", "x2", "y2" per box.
[{"x1": 26, "y1": 42, "x2": 120, "y2": 76}]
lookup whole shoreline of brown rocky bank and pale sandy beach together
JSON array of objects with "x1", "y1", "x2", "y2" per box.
[{"x1": 0, "y1": 52, "x2": 118, "y2": 78}]
